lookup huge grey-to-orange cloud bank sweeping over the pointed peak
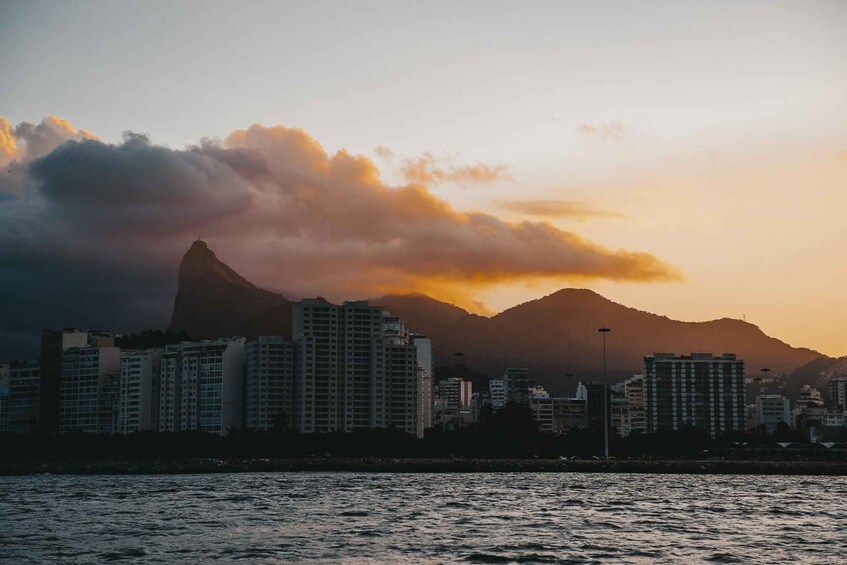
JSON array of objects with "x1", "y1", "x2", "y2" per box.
[{"x1": 0, "y1": 117, "x2": 680, "y2": 360}]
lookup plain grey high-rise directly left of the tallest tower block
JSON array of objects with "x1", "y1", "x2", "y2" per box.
[{"x1": 245, "y1": 336, "x2": 294, "y2": 430}]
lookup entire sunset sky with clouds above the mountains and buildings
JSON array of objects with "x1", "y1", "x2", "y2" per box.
[{"x1": 0, "y1": 0, "x2": 847, "y2": 357}]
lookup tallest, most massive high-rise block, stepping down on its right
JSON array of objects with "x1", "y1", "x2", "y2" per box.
[{"x1": 292, "y1": 299, "x2": 424, "y2": 435}]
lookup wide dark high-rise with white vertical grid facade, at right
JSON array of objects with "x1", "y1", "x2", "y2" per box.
[{"x1": 643, "y1": 353, "x2": 745, "y2": 437}]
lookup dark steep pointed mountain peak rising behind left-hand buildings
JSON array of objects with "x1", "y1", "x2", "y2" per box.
[{"x1": 169, "y1": 240, "x2": 291, "y2": 339}]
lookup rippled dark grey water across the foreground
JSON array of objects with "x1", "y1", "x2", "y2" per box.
[{"x1": 0, "y1": 473, "x2": 847, "y2": 563}]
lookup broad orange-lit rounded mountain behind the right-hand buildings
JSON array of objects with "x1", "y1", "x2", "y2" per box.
[{"x1": 432, "y1": 289, "x2": 820, "y2": 390}]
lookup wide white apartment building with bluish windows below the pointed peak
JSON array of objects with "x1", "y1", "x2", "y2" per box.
[{"x1": 159, "y1": 337, "x2": 246, "y2": 435}]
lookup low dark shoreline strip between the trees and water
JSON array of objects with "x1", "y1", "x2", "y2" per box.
[{"x1": 0, "y1": 457, "x2": 847, "y2": 476}]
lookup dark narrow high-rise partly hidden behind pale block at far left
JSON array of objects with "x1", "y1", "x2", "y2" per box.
[{"x1": 38, "y1": 328, "x2": 88, "y2": 433}]
